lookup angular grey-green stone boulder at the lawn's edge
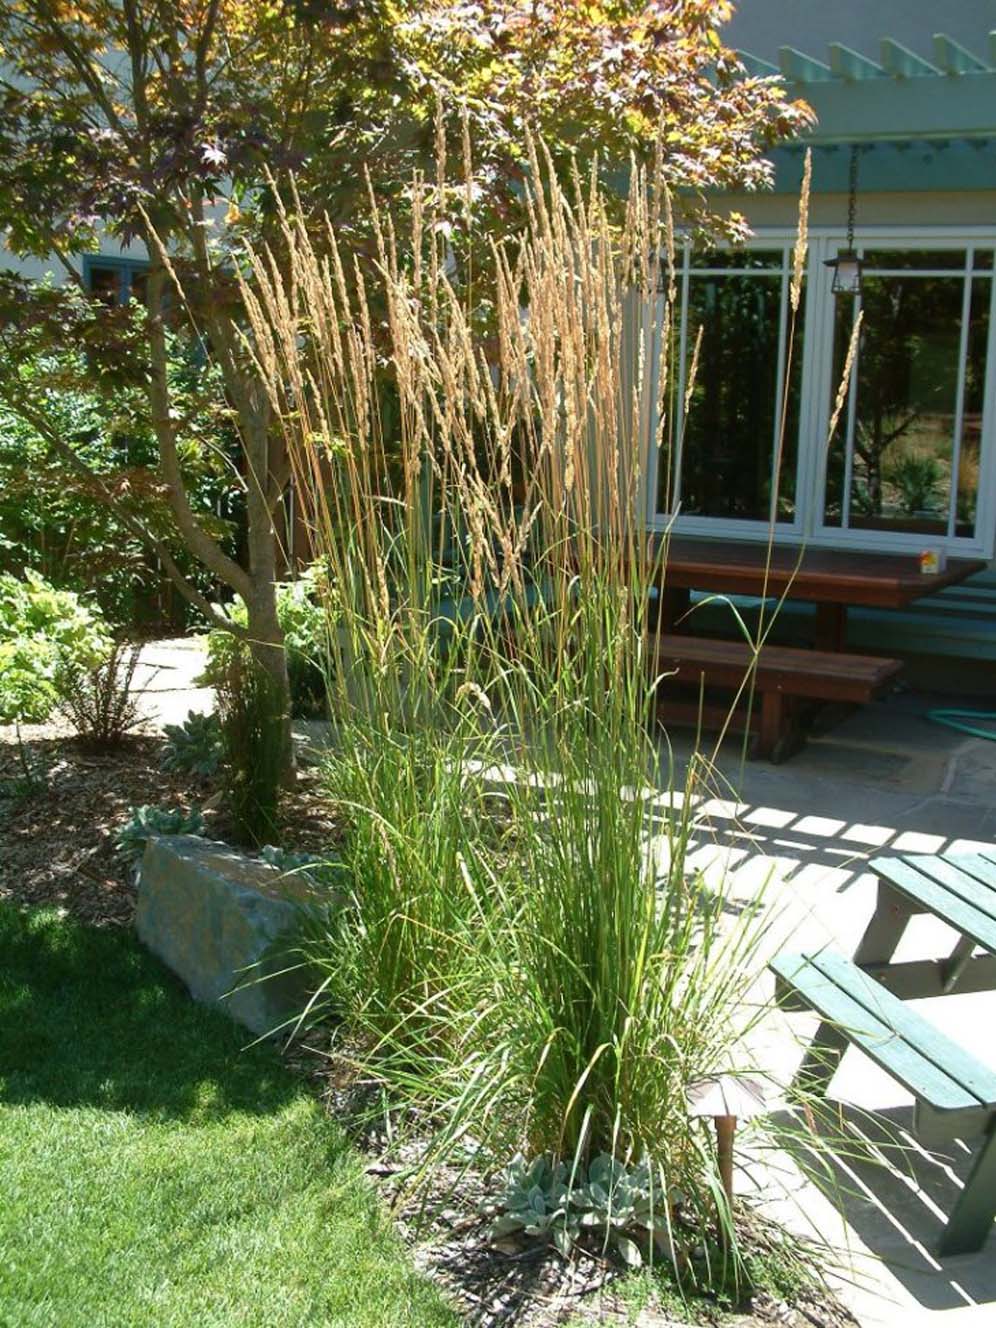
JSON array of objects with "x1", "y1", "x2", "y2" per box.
[{"x1": 135, "y1": 835, "x2": 332, "y2": 1035}]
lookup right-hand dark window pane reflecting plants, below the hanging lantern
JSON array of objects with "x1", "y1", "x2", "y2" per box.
[{"x1": 825, "y1": 251, "x2": 989, "y2": 537}]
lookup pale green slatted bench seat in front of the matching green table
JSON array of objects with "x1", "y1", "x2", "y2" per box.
[{"x1": 770, "y1": 950, "x2": 996, "y2": 1255}]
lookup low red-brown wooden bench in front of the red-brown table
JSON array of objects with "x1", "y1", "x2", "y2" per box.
[{"x1": 656, "y1": 633, "x2": 902, "y2": 761}]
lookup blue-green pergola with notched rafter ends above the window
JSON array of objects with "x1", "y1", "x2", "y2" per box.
[{"x1": 740, "y1": 32, "x2": 996, "y2": 193}]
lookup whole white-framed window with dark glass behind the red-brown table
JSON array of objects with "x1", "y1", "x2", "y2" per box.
[{"x1": 651, "y1": 228, "x2": 996, "y2": 556}]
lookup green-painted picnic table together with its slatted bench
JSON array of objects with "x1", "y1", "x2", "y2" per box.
[{"x1": 770, "y1": 849, "x2": 996, "y2": 1255}]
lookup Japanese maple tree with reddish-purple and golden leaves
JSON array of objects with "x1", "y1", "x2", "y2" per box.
[{"x1": 0, "y1": 0, "x2": 809, "y2": 770}]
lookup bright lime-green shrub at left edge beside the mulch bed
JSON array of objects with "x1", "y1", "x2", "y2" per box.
[{"x1": 0, "y1": 570, "x2": 112, "y2": 724}]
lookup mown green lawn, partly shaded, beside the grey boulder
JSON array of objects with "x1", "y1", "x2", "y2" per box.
[{"x1": 0, "y1": 906, "x2": 458, "y2": 1328}]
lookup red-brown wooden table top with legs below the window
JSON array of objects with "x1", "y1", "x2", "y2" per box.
[{"x1": 661, "y1": 535, "x2": 987, "y2": 651}]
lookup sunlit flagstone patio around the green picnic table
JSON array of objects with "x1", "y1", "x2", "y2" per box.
[{"x1": 675, "y1": 692, "x2": 996, "y2": 1328}]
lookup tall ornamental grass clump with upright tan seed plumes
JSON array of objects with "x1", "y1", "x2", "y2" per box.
[{"x1": 243, "y1": 129, "x2": 818, "y2": 1280}]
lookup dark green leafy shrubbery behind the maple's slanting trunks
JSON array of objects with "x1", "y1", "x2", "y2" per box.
[{"x1": 0, "y1": 342, "x2": 243, "y2": 629}]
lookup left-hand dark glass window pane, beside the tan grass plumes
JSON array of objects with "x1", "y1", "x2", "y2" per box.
[{"x1": 661, "y1": 250, "x2": 802, "y2": 522}]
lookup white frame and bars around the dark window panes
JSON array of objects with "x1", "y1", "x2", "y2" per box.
[{"x1": 645, "y1": 226, "x2": 996, "y2": 558}]
